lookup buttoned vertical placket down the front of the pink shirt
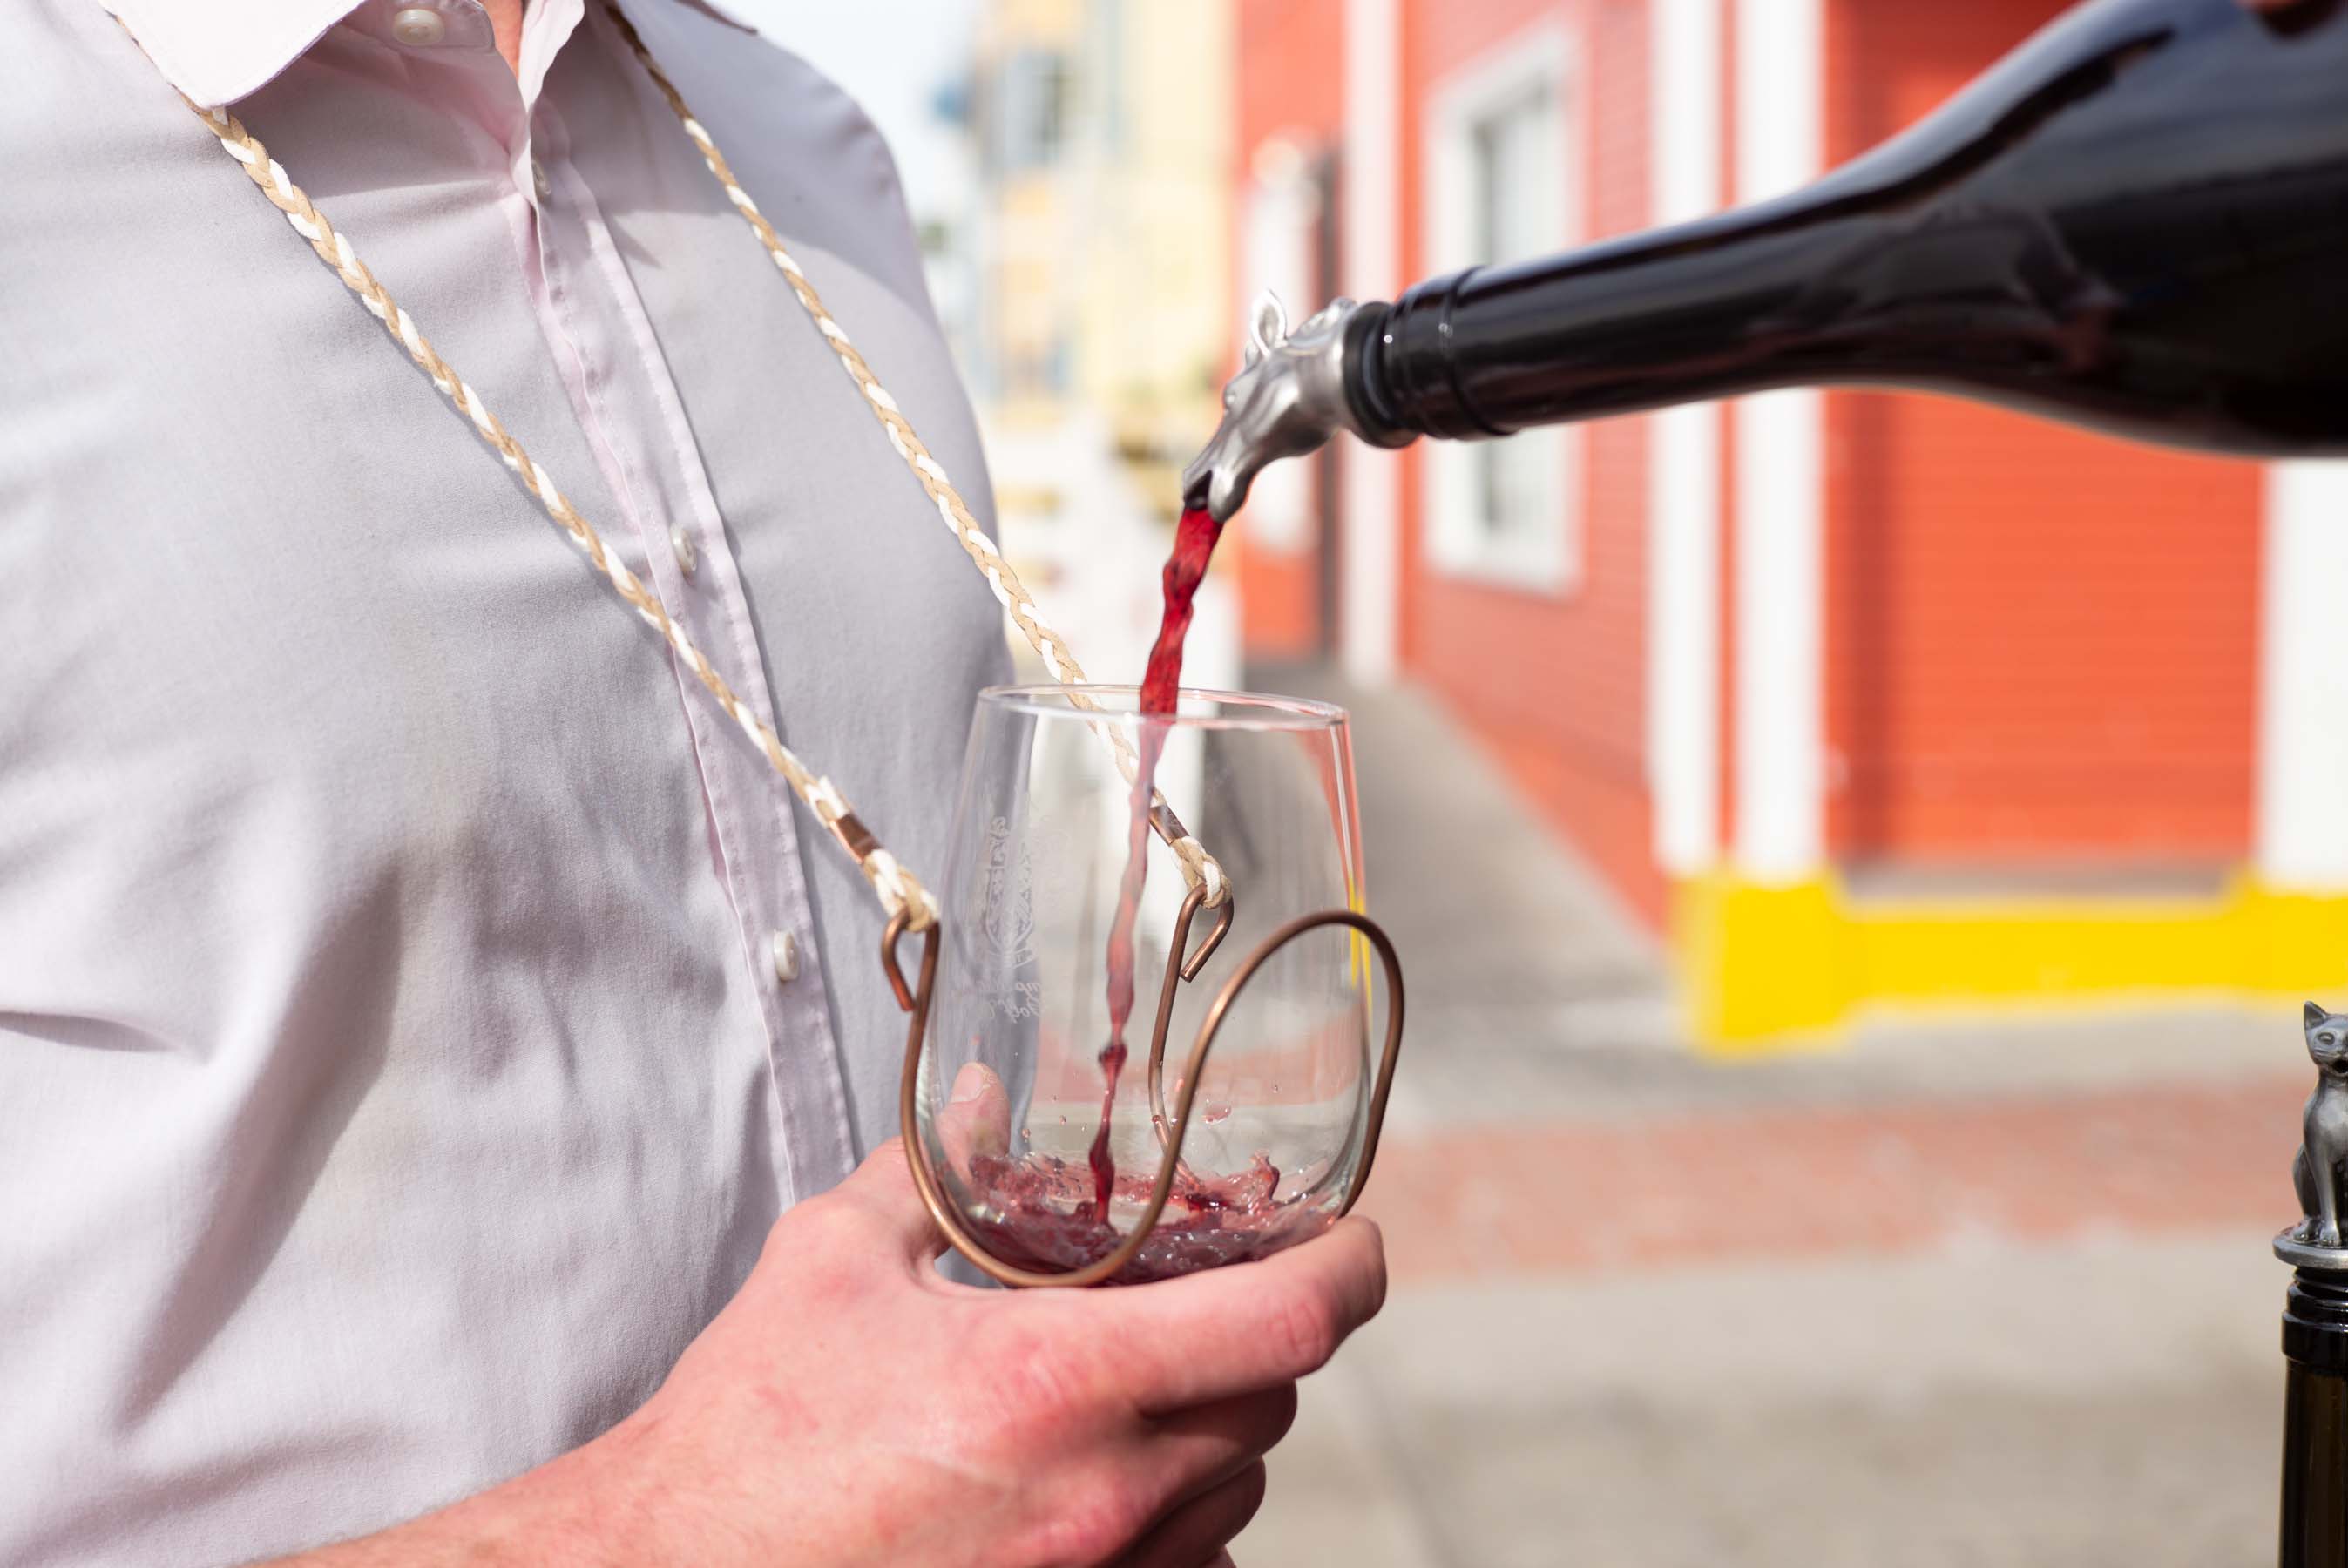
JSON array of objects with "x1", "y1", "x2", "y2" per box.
[{"x1": 443, "y1": 12, "x2": 855, "y2": 1202}]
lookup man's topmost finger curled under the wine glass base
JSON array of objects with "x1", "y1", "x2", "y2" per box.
[{"x1": 1097, "y1": 1219, "x2": 1385, "y2": 1416}]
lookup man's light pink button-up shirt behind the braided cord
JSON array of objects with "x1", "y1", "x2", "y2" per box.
[{"x1": 0, "y1": 0, "x2": 1003, "y2": 1568}]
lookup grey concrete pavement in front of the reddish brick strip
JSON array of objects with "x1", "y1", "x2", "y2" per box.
[{"x1": 1233, "y1": 1233, "x2": 2283, "y2": 1568}]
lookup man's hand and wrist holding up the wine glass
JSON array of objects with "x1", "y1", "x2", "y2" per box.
[{"x1": 277, "y1": 1065, "x2": 1385, "y2": 1568}]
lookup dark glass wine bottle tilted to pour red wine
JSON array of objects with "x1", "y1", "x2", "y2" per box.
[{"x1": 1343, "y1": 0, "x2": 2348, "y2": 456}]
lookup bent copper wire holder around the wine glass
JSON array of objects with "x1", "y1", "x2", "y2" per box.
[{"x1": 881, "y1": 888, "x2": 1402, "y2": 1287}]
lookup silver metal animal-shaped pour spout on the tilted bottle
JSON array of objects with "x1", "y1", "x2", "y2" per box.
[{"x1": 1181, "y1": 291, "x2": 1411, "y2": 524}]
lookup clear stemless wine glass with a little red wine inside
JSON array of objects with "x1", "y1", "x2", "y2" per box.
[{"x1": 890, "y1": 686, "x2": 1402, "y2": 1284}]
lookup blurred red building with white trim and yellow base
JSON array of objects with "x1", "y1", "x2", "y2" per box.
[{"x1": 1230, "y1": 0, "x2": 2348, "y2": 1049}]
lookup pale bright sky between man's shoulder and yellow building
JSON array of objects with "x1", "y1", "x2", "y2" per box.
[{"x1": 726, "y1": 0, "x2": 979, "y2": 213}]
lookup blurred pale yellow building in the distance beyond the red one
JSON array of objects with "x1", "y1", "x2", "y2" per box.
[{"x1": 951, "y1": 0, "x2": 1240, "y2": 704}]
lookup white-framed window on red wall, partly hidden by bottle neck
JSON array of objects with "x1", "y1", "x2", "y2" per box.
[{"x1": 1425, "y1": 26, "x2": 1580, "y2": 591}]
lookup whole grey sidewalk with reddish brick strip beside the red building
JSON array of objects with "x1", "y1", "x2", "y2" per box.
[{"x1": 1233, "y1": 672, "x2": 2305, "y2": 1568}]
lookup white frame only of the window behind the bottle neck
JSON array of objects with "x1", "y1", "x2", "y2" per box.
[{"x1": 1420, "y1": 21, "x2": 1590, "y2": 596}]
